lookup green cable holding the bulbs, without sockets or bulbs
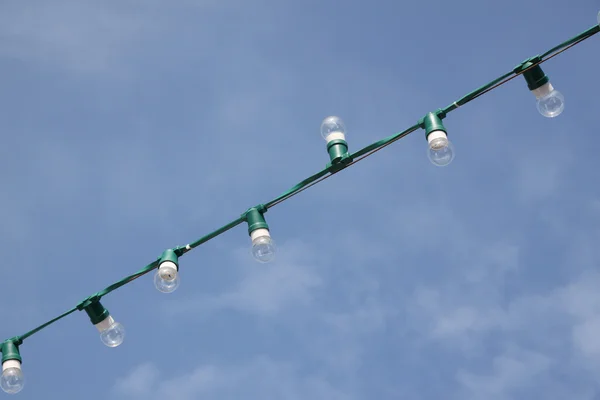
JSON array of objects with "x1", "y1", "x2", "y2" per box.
[{"x1": 2, "y1": 25, "x2": 600, "y2": 343}]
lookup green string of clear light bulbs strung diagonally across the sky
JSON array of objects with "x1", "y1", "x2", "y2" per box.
[{"x1": 0, "y1": 20, "x2": 600, "y2": 393}]
